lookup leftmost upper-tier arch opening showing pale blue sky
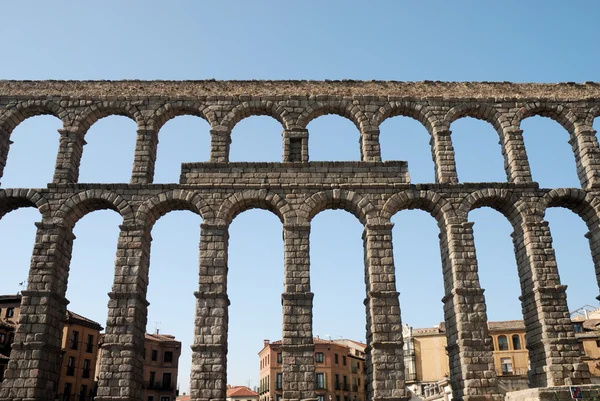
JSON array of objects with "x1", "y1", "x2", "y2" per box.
[{"x1": 1, "y1": 115, "x2": 63, "y2": 188}]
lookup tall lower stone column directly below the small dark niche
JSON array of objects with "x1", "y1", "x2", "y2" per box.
[{"x1": 281, "y1": 223, "x2": 316, "y2": 400}]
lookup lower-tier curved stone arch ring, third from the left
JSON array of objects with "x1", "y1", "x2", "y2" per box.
[{"x1": 136, "y1": 189, "x2": 215, "y2": 228}]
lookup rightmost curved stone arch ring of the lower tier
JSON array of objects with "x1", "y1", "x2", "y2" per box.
[{"x1": 536, "y1": 188, "x2": 600, "y2": 231}]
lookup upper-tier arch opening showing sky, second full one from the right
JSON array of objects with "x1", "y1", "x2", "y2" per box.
[{"x1": 451, "y1": 117, "x2": 506, "y2": 182}]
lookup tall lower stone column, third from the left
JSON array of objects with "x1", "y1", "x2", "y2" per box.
[{"x1": 190, "y1": 223, "x2": 229, "y2": 401}]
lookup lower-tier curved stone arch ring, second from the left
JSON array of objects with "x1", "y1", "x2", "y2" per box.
[{"x1": 54, "y1": 189, "x2": 135, "y2": 228}]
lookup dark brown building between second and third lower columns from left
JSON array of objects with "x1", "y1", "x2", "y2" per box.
[{"x1": 143, "y1": 332, "x2": 181, "y2": 401}]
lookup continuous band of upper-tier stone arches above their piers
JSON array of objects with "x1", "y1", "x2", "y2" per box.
[{"x1": 0, "y1": 99, "x2": 600, "y2": 133}]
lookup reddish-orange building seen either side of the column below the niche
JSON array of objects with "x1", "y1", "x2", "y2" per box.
[{"x1": 258, "y1": 337, "x2": 366, "y2": 401}]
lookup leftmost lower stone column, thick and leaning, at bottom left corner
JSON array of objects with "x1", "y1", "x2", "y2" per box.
[{"x1": 0, "y1": 223, "x2": 75, "y2": 401}]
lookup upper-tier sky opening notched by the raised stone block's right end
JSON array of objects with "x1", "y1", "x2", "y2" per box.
[{"x1": 379, "y1": 116, "x2": 435, "y2": 184}]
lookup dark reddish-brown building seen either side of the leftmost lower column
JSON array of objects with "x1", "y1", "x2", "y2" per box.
[{"x1": 0, "y1": 294, "x2": 103, "y2": 401}]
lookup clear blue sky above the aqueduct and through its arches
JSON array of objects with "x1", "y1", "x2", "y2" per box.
[{"x1": 0, "y1": 0, "x2": 600, "y2": 392}]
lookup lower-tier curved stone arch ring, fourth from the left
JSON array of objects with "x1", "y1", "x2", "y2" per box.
[{"x1": 216, "y1": 189, "x2": 294, "y2": 226}]
